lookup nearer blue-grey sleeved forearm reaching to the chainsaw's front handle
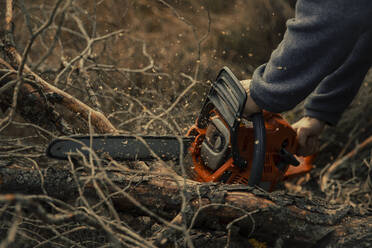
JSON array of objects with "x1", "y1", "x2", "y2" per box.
[{"x1": 250, "y1": 0, "x2": 372, "y2": 120}]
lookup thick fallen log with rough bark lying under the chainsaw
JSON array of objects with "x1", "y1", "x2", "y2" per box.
[{"x1": 0, "y1": 166, "x2": 372, "y2": 247}]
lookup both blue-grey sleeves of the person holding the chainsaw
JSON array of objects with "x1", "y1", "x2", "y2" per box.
[{"x1": 250, "y1": 0, "x2": 372, "y2": 125}]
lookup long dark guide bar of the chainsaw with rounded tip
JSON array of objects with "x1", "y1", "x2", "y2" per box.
[{"x1": 47, "y1": 135, "x2": 195, "y2": 161}]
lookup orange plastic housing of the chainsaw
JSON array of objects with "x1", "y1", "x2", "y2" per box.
[{"x1": 188, "y1": 111, "x2": 314, "y2": 191}]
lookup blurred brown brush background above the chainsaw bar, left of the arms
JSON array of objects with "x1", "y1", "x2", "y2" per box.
[{"x1": 3, "y1": 0, "x2": 293, "y2": 134}]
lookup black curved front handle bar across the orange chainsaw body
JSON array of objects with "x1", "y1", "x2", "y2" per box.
[{"x1": 248, "y1": 112, "x2": 266, "y2": 186}]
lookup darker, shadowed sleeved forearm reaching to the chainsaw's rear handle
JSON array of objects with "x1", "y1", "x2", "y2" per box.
[{"x1": 305, "y1": 30, "x2": 372, "y2": 125}]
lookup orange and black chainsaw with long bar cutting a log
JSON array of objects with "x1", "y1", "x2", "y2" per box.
[{"x1": 47, "y1": 67, "x2": 314, "y2": 191}]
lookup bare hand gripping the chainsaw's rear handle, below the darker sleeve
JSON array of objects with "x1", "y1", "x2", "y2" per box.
[{"x1": 292, "y1": 116, "x2": 325, "y2": 156}]
